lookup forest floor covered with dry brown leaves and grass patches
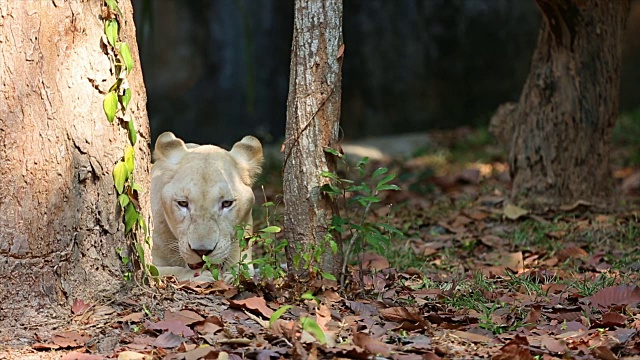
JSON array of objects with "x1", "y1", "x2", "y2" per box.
[{"x1": 0, "y1": 121, "x2": 640, "y2": 360}]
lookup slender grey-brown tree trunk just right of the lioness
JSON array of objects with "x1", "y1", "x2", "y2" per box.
[{"x1": 283, "y1": 0, "x2": 342, "y2": 276}]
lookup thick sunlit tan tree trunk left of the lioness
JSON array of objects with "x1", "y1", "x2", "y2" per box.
[{"x1": 0, "y1": 0, "x2": 150, "y2": 339}]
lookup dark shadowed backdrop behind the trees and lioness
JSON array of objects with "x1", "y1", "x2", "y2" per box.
[{"x1": 133, "y1": 0, "x2": 640, "y2": 144}]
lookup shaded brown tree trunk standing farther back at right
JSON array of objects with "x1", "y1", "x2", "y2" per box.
[{"x1": 492, "y1": 0, "x2": 629, "y2": 208}]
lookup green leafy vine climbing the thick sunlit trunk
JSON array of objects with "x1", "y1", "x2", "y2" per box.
[{"x1": 102, "y1": 0, "x2": 158, "y2": 279}]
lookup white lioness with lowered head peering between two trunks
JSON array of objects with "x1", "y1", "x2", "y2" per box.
[{"x1": 151, "y1": 132, "x2": 263, "y2": 281}]
